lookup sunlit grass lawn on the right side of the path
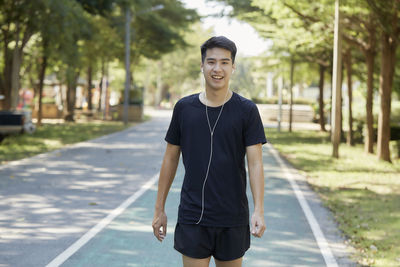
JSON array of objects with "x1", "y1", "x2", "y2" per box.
[{"x1": 265, "y1": 129, "x2": 400, "y2": 267}]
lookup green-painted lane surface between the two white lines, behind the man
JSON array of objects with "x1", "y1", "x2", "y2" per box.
[{"x1": 62, "y1": 146, "x2": 325, "y2": 267}]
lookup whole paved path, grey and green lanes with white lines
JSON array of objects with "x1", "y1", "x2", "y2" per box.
[{"x1": 0, "y1": 108, "x2": 356, "y2": 266}]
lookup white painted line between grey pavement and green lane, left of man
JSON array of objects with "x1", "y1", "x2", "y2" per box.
[{"x1": 46, "y1": 174, "x2": 158, "y2": 267}]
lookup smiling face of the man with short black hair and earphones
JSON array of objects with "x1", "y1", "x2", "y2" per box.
[{"x1": 201, "y1": 47, "x2": 235, "y2": 90}]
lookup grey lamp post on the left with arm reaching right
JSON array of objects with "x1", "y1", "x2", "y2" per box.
[{"x1": 123, "y1": 4, "x2": 164, "y2": 125}]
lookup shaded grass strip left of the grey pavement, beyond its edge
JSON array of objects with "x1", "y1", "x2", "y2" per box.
[{"x1": 0, "y1": 121, "x2": 133, "y2": 164}]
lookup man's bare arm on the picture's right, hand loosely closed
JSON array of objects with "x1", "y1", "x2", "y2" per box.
[{"x1": 246, "y1": 144, "x2": 266, "y2": 237}]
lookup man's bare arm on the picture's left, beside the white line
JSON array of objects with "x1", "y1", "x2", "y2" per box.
[{"x1": 152, "y1": 143, "x2": 181, "y2": 241}]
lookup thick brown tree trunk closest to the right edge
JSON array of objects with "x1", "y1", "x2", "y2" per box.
[{"x1": 377, "y1": 32, "x2": 397, "y2": 162}]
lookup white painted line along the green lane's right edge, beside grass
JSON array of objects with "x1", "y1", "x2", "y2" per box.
[{"x1": 267, "y1": 144, "x2": 338, "y2": 267}]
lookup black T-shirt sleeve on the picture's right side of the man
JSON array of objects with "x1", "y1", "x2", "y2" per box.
[{"x1": 244, "y1": 103, "x2": 267, "y2": 146}]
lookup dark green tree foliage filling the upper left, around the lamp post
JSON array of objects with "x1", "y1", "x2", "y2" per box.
[{"x1": 0, "y1": 0, "x2": 199, "y2": 112}]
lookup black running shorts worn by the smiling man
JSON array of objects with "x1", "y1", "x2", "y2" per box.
[{"x1": 174, "y1": 223, "x2": 250, "y2": 261}]
